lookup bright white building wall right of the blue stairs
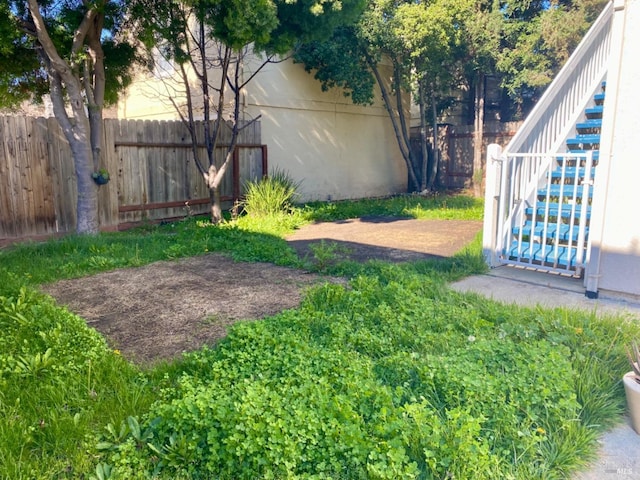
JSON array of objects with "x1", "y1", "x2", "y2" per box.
[{"x1": 585, "y1": 0, "x2": 640, "y2": 295}]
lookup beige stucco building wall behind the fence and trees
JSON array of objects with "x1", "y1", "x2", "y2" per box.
[{"x1": 118, "y1": 54, "x2": 407, "y2": 201}]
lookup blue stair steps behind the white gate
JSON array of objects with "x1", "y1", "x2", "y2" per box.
[{"x1": 502, "y1": 82, "x2": 606, "y2": 276}]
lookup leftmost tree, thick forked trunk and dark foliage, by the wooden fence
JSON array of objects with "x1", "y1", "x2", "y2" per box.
[{"x1": 0, "y1": 0, "x2": 134, "y2": 233}]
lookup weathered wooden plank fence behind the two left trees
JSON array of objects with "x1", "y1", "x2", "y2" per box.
[{"x1": 0, "y1": 116, "x2": 267, "y2": 243}]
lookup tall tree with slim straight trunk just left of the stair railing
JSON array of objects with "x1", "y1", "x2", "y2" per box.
[{"x1": 458, "y1": 0, "x2": 606, "y2": 196}]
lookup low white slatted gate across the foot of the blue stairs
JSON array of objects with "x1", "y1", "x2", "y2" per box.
[{"x1": 494, "y1": 152, "x2": 594, "y2": 275}]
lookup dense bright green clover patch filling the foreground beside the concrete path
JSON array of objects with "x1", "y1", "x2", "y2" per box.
[{"x1": 95, "y1": 274, "x2": 638, "y2": 479}]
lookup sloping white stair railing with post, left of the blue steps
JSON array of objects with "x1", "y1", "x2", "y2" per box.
[{"x1": 483, "y1": 2, "x2": 613, "y2": 267}]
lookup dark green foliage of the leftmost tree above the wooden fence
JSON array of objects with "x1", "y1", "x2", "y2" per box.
[{"x1": 0, "y1": 0, "x2": 134, "y2": 108}]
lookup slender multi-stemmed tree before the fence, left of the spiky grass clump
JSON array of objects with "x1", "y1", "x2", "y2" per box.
[{"x1": 135, "y1": 0, "x2": 364, "y2": 223}]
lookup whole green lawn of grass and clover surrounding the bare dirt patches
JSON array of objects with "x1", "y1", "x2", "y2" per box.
[{"x1": 0, "y1": 196, "x2": 640, "y2": 479}]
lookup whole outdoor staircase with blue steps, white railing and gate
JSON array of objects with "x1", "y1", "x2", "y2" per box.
[{"x1": 482, "y1": 2, "x2": 614, "y2": 277}]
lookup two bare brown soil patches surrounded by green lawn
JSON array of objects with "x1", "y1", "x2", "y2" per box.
[{"x1": 42, "y1": 218, "x2": 482, "y2": 364}]
